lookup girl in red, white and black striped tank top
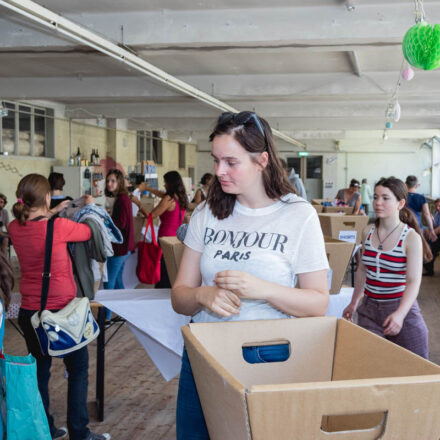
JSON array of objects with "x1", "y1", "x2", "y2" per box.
[{"x1": 343, "y1": 177, "x2": 432, "y2": 358}]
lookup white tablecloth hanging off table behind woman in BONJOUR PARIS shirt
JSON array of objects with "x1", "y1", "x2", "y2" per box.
[{"x1": 95, "y1": 287, "x2": 353, "y2": 380}]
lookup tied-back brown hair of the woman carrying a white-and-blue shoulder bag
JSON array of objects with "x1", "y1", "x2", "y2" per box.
[{"x1": 12, "y1": 174, "x2": 50, "y2": 225}]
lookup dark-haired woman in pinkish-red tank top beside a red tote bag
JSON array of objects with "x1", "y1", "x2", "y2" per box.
[{"x1": 145, "y1": 171, "x2": 188, "y2": 289}]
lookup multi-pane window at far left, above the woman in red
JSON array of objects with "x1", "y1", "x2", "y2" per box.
[{"x1": 0, "y1": 102, "x2": 54, "y2": 157}]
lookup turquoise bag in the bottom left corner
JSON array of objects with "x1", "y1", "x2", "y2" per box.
[{"x1": 0, "y1": 354, "x2": 52, "y2": 440}]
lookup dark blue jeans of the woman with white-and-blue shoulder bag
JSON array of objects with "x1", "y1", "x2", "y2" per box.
[{"x1": 18, "y1": 309, "x2": 90, "y2": 440}]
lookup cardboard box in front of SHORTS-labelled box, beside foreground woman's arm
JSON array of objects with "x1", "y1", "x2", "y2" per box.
[{"x1": 324, "y1": 236, "x2": 355, "y2": 293}]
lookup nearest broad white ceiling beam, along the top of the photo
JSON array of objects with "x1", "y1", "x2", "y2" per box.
[{"x1": 0, "y1": 2, "x2": 430, "y2": 50}]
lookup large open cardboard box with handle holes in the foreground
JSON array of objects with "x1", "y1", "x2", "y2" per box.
[{"x1": 182, "y1": 317, "x2": 440, "y2": 440}]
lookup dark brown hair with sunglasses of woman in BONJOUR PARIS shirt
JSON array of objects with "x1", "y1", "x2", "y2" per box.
[{"x1": 206, "y1": 112, "x2": 296, "y2": 220}]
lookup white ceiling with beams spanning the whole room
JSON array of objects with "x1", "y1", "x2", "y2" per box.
[{"x1": 0, "y1": 0, "x2": 440, "y2": 149}]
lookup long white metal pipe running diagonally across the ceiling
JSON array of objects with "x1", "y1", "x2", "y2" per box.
[{"x1": 0, "y1": 0, "x2": 306, "y2": 149}]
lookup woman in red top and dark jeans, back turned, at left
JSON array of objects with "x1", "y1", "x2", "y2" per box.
[{"x1": 8, "y1": 174, "x2": 110, "y2": 440}]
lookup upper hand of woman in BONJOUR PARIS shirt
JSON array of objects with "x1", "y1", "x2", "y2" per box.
[{"x1": 214, "y1": 270, "x2": 265, "y2": 299}]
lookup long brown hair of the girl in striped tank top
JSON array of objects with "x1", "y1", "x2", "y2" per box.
[{"x1": 374, "y1": 176, "x2": 432, "y2": 261}]
